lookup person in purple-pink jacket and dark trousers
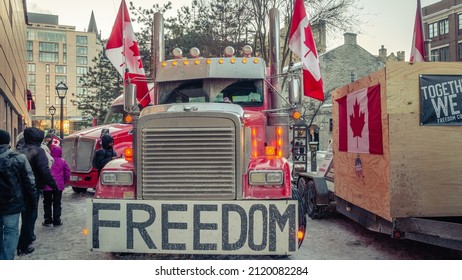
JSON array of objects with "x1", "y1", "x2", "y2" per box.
[{"x1": 42, "y1": 145, "x2": 71, "y2": 227}]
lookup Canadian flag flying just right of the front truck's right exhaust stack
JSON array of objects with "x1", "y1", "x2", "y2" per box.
[{"x1": 289, "y1": 0, "x2": 324, "y2": 101}]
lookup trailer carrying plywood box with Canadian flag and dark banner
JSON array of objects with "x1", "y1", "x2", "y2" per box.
[{"x1": 295, "y1": 62, "x2": 462, "y2": 250}]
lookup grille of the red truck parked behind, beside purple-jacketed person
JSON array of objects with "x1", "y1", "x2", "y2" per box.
[{"x1": 63, "y1": 138, "x2": 95, "y2": 173}]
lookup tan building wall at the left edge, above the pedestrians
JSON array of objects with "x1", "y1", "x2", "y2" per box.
[{"x1": 0, "y1": 0, "x2": 31, "y2": 144}]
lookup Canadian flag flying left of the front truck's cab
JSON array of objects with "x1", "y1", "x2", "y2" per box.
[{"x1": 106, "y1": 0, "x2": 151, "y2": 107}]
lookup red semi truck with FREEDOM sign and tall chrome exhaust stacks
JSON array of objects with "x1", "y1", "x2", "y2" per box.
[{"x1": 80, "y1": 9, "x2": 306, "y2": 255}]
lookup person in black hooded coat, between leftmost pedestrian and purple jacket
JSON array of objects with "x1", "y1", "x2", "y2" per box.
[{"x1": 18, "y1": 127, "x2": 58, "y2": 255}]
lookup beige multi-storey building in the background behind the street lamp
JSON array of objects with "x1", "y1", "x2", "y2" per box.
[{"x1": 25, "y1": 13, "x2": 103, "y2": 135}]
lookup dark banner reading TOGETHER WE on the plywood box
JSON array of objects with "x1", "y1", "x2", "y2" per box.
[{"x1": 420, "y1": 75, "x2": 462, "y2": 125}]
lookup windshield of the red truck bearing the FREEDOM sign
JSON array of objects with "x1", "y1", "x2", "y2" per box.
[{"x1": 159, "y1": 79, "x2": 264, "y2": 107}]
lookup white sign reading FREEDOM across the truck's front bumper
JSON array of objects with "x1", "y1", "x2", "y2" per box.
[{"x1": 87, "y1": 199, "x2": 298, "y2": 255}]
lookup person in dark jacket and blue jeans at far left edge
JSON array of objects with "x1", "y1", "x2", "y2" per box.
[{"x1": 0, "y1": 130, "x2": 38, "y2": 260}]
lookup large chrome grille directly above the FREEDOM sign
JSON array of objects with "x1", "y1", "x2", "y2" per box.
[{"x1": 139, "y1": 124, "x2": 236, "y2": 199}]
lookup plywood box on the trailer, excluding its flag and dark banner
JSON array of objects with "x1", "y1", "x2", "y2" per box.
[{"x1": 332, "y1": 62, "x2": 462, "y2": 221}]
